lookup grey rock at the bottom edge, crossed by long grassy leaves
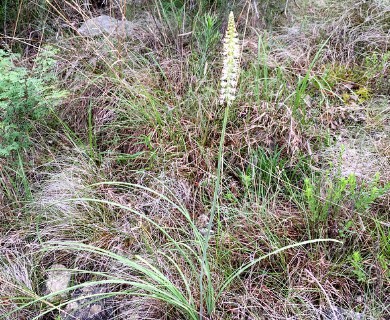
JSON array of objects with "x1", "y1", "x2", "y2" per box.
[{"x1": 61, "y1": 286, "x2": 115, "y2": 320}]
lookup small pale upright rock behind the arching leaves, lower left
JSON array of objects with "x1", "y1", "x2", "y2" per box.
[{"x1": 46, "y1": 264, "x2": 71, "y2": 300}]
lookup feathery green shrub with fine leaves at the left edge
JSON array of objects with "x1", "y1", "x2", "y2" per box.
[{"x1": 0, "y1": 48, "x2": 64, "y2": 157}]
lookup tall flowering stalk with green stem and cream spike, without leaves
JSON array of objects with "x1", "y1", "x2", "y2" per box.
[{"x1": 199, "y1": 12, "x2": 240, "y2": 320}]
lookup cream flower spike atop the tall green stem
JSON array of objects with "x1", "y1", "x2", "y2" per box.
[{"x1": 219, "y1": 12, "x2": 240, "y2": 105}]
